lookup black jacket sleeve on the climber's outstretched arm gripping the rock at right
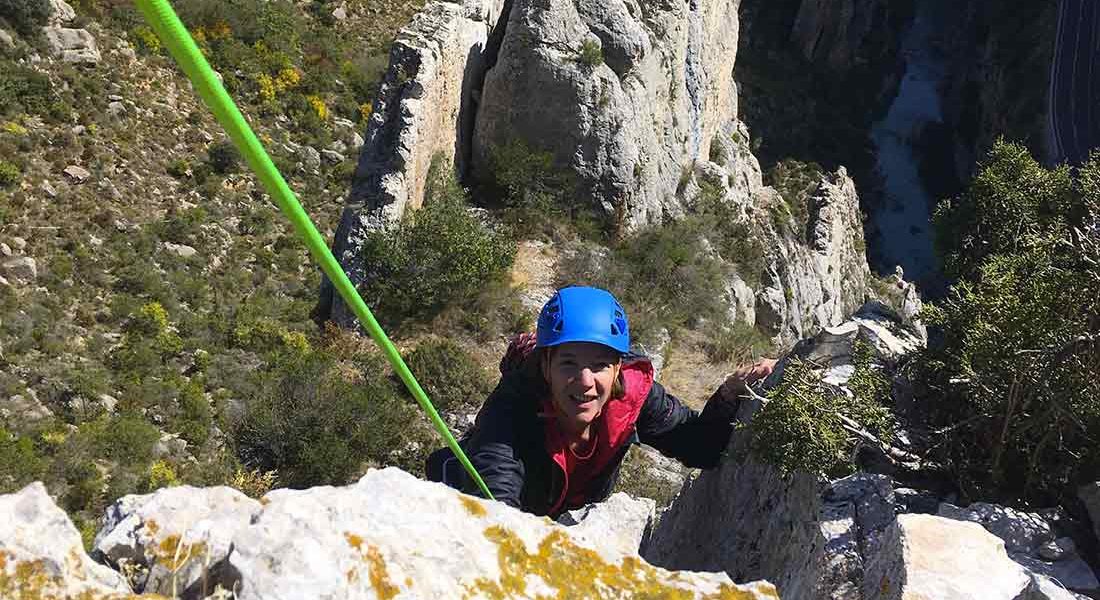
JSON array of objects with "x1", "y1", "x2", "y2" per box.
[{"x1": 638, "y1": 382, "x2": 736, "y2": 469}]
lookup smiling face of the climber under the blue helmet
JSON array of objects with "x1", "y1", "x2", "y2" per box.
[{"x1": 542, "y1": 341, "x2": 623, "y2": 435}]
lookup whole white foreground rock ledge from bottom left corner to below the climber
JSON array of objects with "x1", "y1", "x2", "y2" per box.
[{"x1": 0, "y1": 468, "x2": 779, "y2": 600}]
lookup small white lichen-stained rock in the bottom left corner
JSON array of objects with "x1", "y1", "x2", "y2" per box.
[{"x1": 0, "y1": 483, "x2": 130, "y2": 599}]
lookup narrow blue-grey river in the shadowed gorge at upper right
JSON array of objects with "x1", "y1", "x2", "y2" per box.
[{"x1": 871, "y1": 0, "x2": 952, "y2": 291}]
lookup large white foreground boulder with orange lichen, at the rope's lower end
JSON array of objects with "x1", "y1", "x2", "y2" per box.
[{"x1": 230, "y1": 468, "x2": 778, "y2": 600}]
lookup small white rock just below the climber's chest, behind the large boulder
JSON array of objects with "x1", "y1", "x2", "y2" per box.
[{"x1": 558, "y1": 492, "x2": 657, "y2": 554}]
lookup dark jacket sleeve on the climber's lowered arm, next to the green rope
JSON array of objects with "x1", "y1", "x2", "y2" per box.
[{"x1": 463, "y1": 375, "x2": 526, "y2": 509}]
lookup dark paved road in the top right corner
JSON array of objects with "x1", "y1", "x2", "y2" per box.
[{"x1": 1051, "y1": 0, "x2": 1100, "y2": 164}]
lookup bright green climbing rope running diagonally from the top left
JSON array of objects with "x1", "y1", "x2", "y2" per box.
[{"x1": 135, "y1": 0, "x2": 493, "y2": 499}]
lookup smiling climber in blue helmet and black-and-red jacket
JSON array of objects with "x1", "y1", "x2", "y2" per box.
[{"x1": 427, "y1": 287, "x2": 776, "y2": 519}]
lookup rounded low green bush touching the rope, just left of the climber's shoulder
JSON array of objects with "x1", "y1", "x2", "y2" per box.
[{"x1": 405, "y1": 338, "x2": 496, "y2": 411}]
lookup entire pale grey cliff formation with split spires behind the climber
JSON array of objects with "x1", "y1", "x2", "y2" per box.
[{"x1": 318, "y1": 1, "x2": 884, "y2": 343}]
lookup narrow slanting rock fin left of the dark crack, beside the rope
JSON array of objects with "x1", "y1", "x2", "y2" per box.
[{"x1": 317, "y1": 0, "x2": 505, "y2": 327}]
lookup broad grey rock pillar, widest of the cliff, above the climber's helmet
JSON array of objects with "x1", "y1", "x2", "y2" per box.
[{"x1": 473, "y1": 0, "x2": 739, "y2": 229}]
